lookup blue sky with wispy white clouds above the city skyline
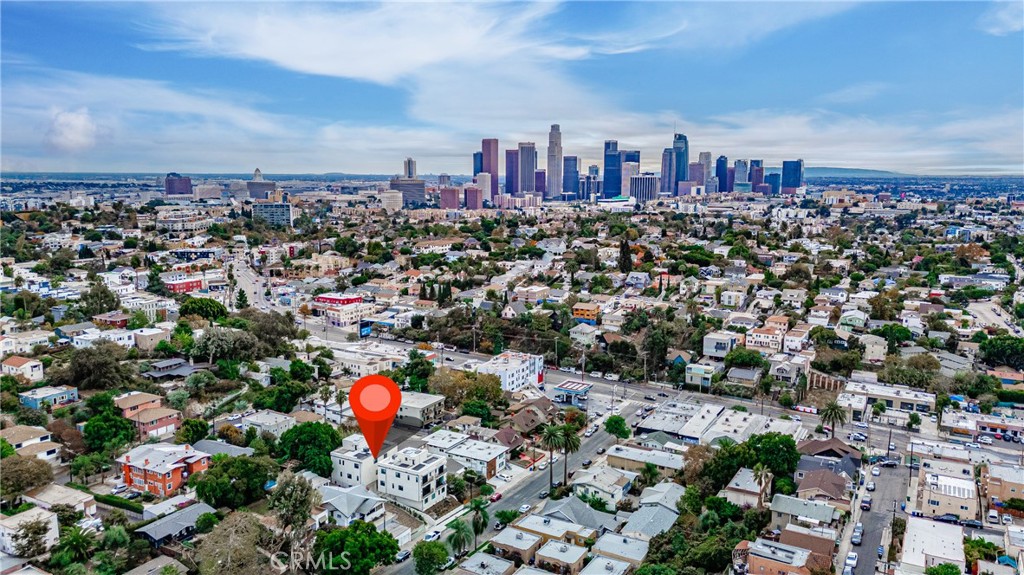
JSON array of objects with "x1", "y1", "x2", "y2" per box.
[{"x1": 0, "y1": 0, "x2": 1024, "y2": 175}]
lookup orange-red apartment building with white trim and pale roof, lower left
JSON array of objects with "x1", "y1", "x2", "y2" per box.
[{"x1": 117, "y1": 443, "x2": 211, "y2": 497}]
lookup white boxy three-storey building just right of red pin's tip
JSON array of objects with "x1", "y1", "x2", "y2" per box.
[{"x1": 377, "y1": 447, "x2": 447, "y2": 512}]
